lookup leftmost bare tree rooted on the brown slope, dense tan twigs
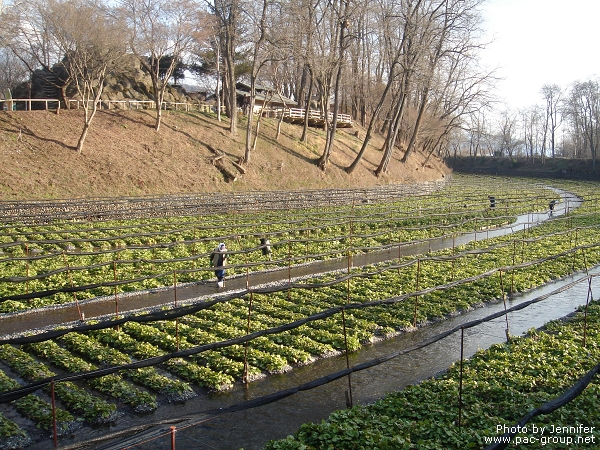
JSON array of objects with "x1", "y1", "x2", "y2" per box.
[{"x1": 48, "y1": 0, "x2": 126, "y2": 153}]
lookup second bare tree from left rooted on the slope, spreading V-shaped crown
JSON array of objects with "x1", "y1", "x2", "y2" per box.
[{"x1": 119, "y1": 0, "x2": 202, "y2": 131}]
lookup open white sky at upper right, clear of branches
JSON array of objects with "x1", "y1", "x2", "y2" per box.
[{"x1": 482, "y1": 0, "x2": 600, "y2": 109}]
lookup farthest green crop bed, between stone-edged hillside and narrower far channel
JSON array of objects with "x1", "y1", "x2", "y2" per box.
[{"x1": 0, "y1": 178, "x2": 544, "y2": 313}]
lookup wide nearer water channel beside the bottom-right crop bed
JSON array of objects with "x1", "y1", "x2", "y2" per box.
[{"x1": 96, "y1": 267, "x2": 600, "y2": 450}]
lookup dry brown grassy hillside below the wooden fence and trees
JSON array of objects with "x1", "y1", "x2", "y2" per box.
[{"x1": 0, "y1": 110, "x2": 449, "y2": 200}]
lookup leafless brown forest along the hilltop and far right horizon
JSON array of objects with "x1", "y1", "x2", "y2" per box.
[{"x1": 0, "y1": 0, "x2": 600, "y2": 169}]
